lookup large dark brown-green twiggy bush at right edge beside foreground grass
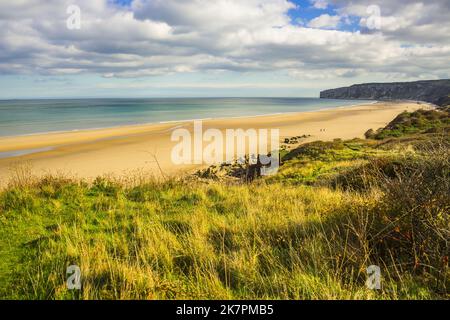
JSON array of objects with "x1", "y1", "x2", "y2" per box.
[{"x1": 334, "y1": 148, "x2": 450, "y2": 292}]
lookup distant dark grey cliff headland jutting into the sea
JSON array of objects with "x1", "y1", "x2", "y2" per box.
[{"x1": 320, "y1": 79, "x2": 450, "y2": 106}]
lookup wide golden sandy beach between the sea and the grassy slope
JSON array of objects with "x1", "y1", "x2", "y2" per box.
[{"x1": 0, "y1": 102, "x2": 429, "y2": 186}]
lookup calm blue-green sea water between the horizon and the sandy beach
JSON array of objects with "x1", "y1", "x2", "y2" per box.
[{"x1": 0, "y1": 98, "x2": 370, "y2": 136}]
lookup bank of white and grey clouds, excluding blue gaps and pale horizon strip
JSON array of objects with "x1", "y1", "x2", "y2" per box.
[{"x1": 0, "y1": 0, "x2": 450, "y2": 84}]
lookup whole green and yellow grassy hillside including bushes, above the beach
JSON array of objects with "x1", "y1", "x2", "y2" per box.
[{"x1": 0, "y1": 111, "x2": 450, "y2": 299}]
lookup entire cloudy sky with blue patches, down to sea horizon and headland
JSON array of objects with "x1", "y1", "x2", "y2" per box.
[{"x1": 0, "y1": 0, "x2": 450, "y2": 99}]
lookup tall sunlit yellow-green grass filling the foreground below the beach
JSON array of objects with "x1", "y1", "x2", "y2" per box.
[{"x1": 1, "y1": 160, "x2": 448, "y2": 299}]
